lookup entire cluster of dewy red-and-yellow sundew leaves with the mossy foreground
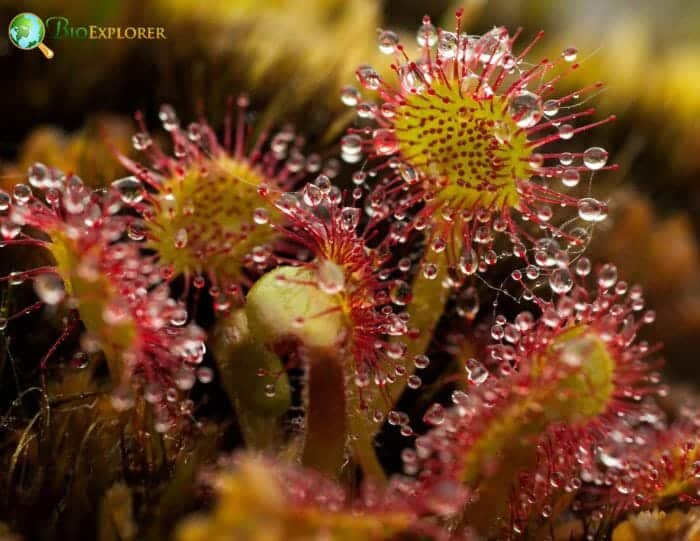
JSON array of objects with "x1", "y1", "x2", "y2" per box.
[{"x1": 0, "y1": 5, "x2": 700, "y2": 541}]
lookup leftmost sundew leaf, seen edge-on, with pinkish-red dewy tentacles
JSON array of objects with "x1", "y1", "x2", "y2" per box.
[{"x1": 0, "y1": 163, "x2": 213, "y2": 431}]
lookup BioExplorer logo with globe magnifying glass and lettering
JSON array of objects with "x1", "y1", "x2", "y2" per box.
[{"x1": 8, "y1": 12, "x2": 167, "y2": 58}]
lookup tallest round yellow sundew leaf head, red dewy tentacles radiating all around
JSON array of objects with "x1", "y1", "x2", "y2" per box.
[{"x1": 341, "y1": 12, "x2": 615, "y2": 285}]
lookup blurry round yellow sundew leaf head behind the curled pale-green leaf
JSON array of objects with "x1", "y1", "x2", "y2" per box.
[{"x1": 113, "y1": 96, "x2": 338, "y2": 312}]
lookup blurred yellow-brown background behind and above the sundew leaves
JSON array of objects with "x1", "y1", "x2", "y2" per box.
[{"x1": 0, "y1": 0, "x2": 700, "y2": 382}]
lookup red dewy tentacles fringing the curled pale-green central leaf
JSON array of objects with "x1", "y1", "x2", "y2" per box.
[{"x1": 275, "y1": 175, "x2": 429, "y2": 404}]
